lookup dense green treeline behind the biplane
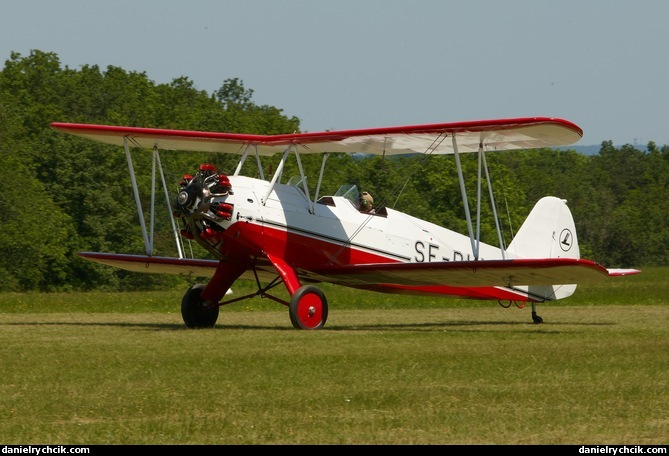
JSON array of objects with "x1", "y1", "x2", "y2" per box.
[{"x1": 0, "y1": 51, "x2": 669, "y2": 291}]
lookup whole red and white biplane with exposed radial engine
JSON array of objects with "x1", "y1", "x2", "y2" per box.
[{"x1": 51, "y1": 117, "x2": 639, "y2": 329}]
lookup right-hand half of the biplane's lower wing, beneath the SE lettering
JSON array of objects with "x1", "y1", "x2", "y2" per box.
[{"x1": 307, "y1": 258, "x2": 640, "y2": 287}]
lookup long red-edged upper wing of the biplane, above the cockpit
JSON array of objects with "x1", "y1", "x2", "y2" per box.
[{"x1": 51, "y1": 117, "x2": 583, "y2": 155}]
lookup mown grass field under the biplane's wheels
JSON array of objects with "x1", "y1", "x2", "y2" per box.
[{"x1": 0, "y1": 268, "x2": 669, "y2": 445}]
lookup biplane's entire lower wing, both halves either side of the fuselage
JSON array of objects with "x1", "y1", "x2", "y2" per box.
[{"x1": 79, "y1": 252, "x2": 640, "y2": 287}]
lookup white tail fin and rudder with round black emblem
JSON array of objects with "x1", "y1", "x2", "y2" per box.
[{"x1": 507, "y1": 196, "x2": 580, "y2": 300}]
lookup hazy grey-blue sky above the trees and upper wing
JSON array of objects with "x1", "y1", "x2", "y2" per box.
[{"x1": 0, "y1": 0, "x2": 669, "y2": 145}]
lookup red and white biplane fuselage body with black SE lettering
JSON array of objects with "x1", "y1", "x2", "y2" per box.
[{"x1": 177, "y1": 176, "x2": 502, "y2": 270}]
